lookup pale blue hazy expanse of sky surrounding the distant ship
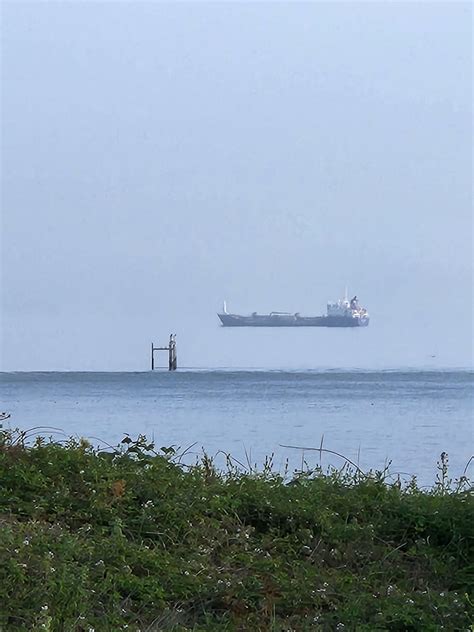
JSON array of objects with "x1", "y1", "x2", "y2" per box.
[{"x1": 1, "y1": 0, "x2": 473, "y2": 370}]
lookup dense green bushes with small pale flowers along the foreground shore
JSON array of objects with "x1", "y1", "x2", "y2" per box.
[{"x1": 0, "y1": 430, "x2": 474, "y2": 632}]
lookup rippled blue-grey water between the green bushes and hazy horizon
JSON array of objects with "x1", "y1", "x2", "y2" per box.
[{"x1": 0, "y1": 370, "x2": 474, "y2": 485}]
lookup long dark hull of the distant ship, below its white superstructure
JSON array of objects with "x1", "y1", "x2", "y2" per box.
[{"x1": 218, "y1": 314, "x2": 369, "y2": 327}]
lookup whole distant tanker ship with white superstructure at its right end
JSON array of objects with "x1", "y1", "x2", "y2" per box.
[{"x1": 217, "y1": 296, "x2": 370, "y2": 327}]
